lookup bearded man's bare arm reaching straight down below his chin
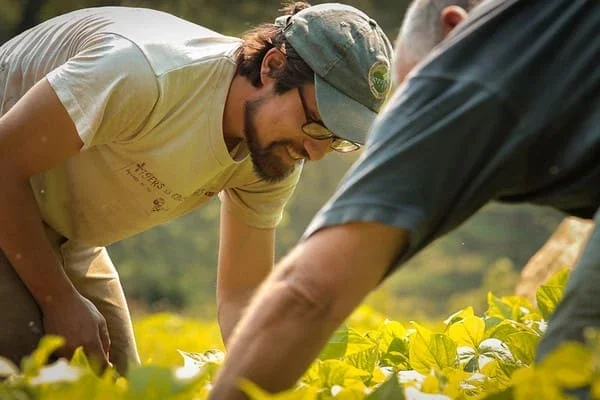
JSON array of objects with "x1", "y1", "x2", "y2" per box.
[{"x1": 217, "y1": 207, "x2": 275, "y2": 344}]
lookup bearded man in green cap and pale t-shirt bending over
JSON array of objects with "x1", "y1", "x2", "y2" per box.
[{"x1": 0, "y1": 2, "x2": 392, "y2": 372}]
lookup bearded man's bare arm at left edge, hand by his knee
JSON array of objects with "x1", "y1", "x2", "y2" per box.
[{"x1": 0, "y1": 79, "x2": 109, "y2": 364}]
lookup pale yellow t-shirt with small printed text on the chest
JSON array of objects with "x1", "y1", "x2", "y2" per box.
[{"x1": 0, "y1": 7, "x2": 301, "y2": 245}]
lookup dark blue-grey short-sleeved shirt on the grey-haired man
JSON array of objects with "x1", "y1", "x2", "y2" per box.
[{"x1": 304, "y1": 0, "x2": 600, "y2": 274}]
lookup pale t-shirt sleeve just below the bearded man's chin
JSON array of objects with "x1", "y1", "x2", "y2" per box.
[{"x1": 219, "y1": 165, "x2": 302, "y2": 229}]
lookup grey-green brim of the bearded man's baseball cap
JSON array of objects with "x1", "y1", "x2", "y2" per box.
[{"x1": 315, "y1": 74, "x2": 377, "y2": 144}]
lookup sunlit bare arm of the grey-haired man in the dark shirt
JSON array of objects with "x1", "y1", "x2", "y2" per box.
[{"x1": 211, "y1": 223, "x2": 408, "y2": 400}]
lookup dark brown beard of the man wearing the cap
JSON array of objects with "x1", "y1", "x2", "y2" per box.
[{"x1": 244, "y1": 95, "x2": 301, "y2": 183}]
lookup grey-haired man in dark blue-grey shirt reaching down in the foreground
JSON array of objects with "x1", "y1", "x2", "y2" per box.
[{"x1": 213, "y1": 0, "x2": 600, "y2": 399}]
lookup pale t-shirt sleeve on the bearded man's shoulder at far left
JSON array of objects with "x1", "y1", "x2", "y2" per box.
[{"x1": 46, "y1": 35, "x2": 158, "y2": 149}]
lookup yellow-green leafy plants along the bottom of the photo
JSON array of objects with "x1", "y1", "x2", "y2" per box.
[{"x1": 0, "y1": 271, "x2": 600, "y2": 400}]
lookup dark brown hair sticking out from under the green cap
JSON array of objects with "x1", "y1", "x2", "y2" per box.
[{"x1": 237, "y1": 1, "x2": 314, "y2": 93}]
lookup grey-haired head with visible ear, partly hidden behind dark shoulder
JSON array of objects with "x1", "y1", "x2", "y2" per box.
[{"x1": 394, "y1": 0, "x2": 482, "y2": 83}]
